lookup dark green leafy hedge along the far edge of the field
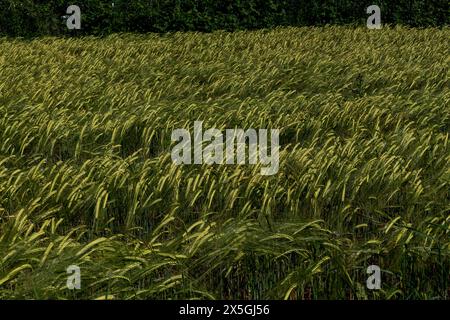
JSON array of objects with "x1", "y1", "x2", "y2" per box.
[{"x1": 0, "y1": 0, "x2": 450, "y2": 36}]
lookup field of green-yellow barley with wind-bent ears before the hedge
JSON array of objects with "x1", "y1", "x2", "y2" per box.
[{"x1": 0, "y1": 27, "x2": 450, "y2": 299}]
